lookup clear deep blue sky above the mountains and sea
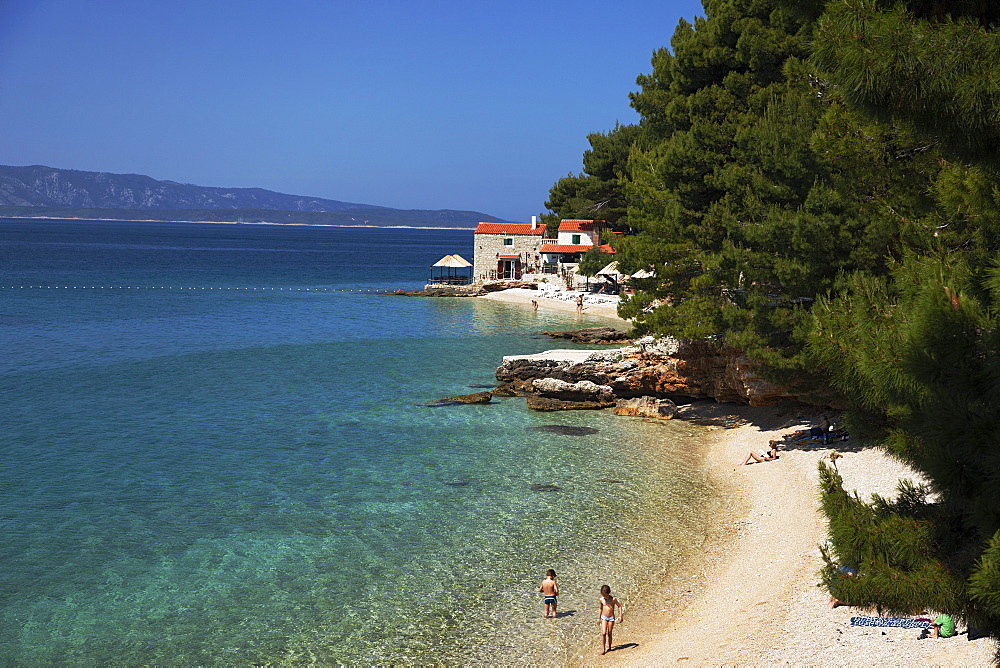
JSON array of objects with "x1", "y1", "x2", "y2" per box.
[{"x1": 0, "y1": 0, "x2": 704, "y2": 220}]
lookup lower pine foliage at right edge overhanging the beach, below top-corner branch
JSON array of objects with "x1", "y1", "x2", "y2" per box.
[{"x1": 809, "y1": 252, "x2": 1000, "y2": 634}]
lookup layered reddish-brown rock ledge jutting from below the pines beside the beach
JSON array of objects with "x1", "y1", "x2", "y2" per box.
[{"x1": 496, "y1": 337, "x2": 795, "y2": 406}]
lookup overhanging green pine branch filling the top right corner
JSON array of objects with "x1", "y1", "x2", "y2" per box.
[{"x1": 814, "y1": 0, "x2": 1000, "y2": 162}]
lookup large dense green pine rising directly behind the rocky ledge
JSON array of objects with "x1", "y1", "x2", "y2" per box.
[{"x1": 618, "y1": 0, "x2": 941, "y2": 397}]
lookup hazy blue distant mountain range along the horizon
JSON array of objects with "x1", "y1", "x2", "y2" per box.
[{"x1": 0, "y1": 165, "x2": 504, "y2": 227}]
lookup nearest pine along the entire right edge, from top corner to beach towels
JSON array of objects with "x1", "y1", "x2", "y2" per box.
[{"x1": 809, "y1": 0, "x2": 1000, "y2": 637}]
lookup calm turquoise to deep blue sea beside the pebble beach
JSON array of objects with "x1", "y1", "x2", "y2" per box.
[{"x1": 0, "y1": 220, "x2": 720, "y2": 664}]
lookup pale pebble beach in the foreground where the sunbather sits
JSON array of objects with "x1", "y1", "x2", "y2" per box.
[{"x1": 596, "y1": 406, "x2": 993, "y2": 666}]
